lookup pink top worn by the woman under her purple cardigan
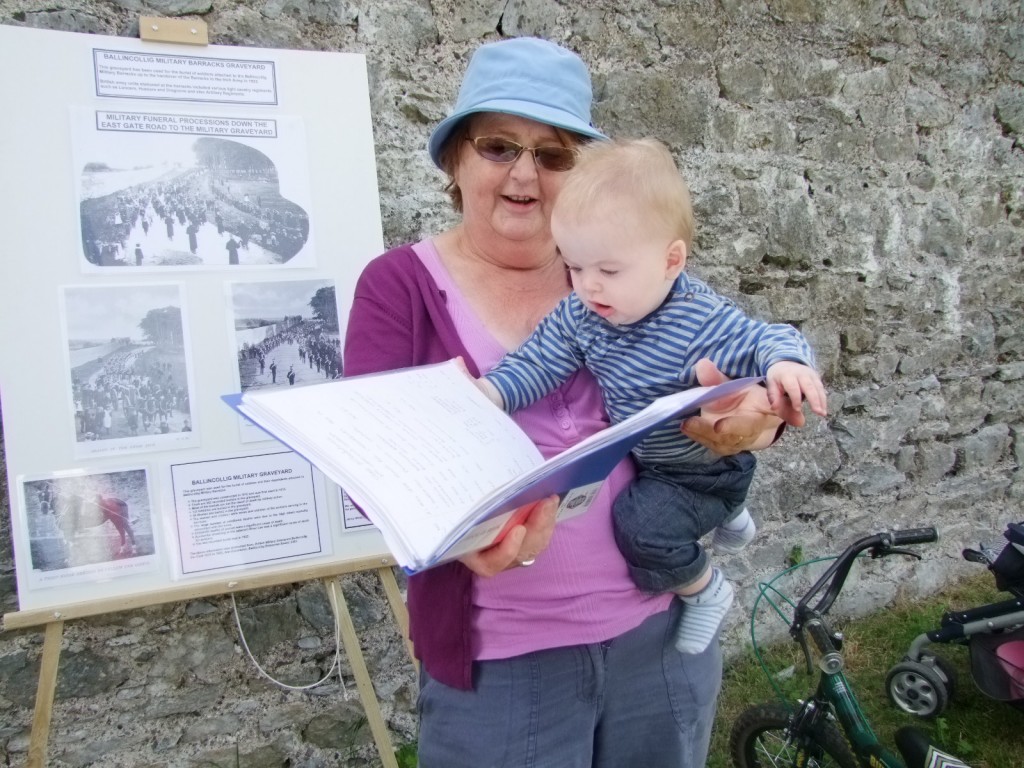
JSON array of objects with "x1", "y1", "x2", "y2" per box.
[{"x1": 414, "y1": 241, "x2": 671, "y2": 659}]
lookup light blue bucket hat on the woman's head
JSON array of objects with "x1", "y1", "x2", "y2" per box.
[{"x1": 427, "y1": 37, "x2": 607, "y2": 168}]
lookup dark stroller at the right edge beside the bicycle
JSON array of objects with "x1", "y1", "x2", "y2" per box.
[{"x1": 886, "y1": 522, "x2": 1024, "y2": 718}]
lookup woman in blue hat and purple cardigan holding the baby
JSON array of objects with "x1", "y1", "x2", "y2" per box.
[{"x1": 345, "y1": 38, "x2": 801, "y2": 768}]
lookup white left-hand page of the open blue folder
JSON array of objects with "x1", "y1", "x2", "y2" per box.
[{"x1": 244, "y1": 364, "x2": 542, "y2": 557}]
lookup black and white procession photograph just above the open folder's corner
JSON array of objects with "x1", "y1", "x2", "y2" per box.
[{"x1": 229, "y1": 280, "x2": 341, "y2": 399}]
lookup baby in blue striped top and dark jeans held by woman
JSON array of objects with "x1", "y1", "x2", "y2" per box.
[{"x1": 477, "y1": 139, "x2": 826, "y2": 653}]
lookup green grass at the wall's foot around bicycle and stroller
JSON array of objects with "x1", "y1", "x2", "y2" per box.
[{"x1": 708, "y1": 570, "x2": 1024, "y2": 768}]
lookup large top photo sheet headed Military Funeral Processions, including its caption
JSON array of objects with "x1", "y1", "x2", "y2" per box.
[{"x1": 73, "y1": 111, "x2": 314, "y2": 271}]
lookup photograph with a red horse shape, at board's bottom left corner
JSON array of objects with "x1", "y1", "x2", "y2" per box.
[{"x1": 22, "y1": 469, "x2": 156, "y2": 571}]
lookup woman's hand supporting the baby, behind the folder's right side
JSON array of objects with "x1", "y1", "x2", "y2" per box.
[{"x1": 682, "y1": 359, "x2": 786, "y2": 456}]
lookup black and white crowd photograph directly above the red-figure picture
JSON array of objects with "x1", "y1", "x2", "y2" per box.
[{"x1": 61, "y1": 284, "x2": 199, "y2": 456}]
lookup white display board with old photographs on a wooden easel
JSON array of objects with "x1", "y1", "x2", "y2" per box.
[{"x1": 0, "y1": 26, "x2": 386, "y2": 611}]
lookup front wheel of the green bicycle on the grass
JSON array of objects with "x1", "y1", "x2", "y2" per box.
[{"x1": 729, "y1": 703, "x2": 858, "y2": 768}]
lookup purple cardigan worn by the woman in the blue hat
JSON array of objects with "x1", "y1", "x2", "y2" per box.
[{"x1": 344, "y1": 245, "x2": 479, "y2": 690}]
